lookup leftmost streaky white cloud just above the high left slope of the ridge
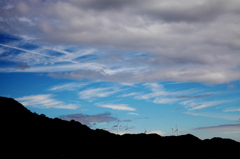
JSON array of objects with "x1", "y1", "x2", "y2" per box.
[{"x1": 16, "y1": 94, "x2": 79, "y2": 109}]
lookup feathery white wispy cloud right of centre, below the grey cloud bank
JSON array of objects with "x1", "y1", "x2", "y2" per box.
[{"x1": 124, "y1": 83, "x2": 211, "y2": 106}]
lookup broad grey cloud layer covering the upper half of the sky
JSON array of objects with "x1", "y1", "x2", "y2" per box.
[{"x1": 0, "y1": 0, "x2": 240, "y2": 84}]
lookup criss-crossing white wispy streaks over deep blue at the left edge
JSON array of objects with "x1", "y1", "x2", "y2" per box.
[{"x1": 0, "y1": 41, "x2": 103, "y2": 72}]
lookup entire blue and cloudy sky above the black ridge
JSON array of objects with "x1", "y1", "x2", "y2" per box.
[{"x1": 0, "y1": 0, "x2": 240, "y2": 141}]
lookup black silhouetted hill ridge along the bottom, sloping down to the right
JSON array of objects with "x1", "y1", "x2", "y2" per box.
[{"x1": 0, "y1": 97, "x2": 240, "y2": 159}]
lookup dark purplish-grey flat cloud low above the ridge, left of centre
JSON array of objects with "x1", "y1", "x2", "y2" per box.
[{"x1": 59, "y1": 112, "x2": 117, "y2": 125}]
